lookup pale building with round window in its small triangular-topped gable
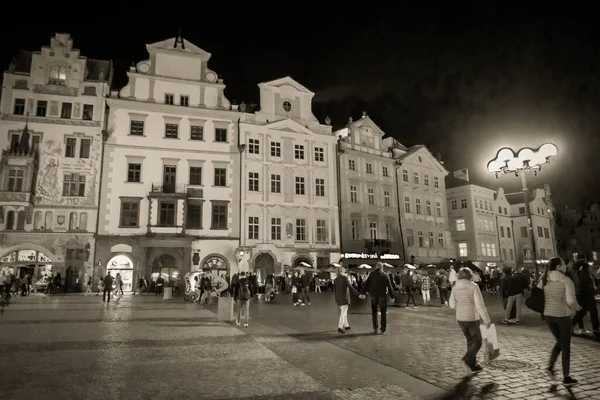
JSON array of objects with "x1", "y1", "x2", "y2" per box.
[{"x1": 239, "y1": 77, "x2": 340, "y2": 280}]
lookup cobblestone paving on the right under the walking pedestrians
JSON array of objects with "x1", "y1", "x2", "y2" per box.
[{"x1": 237, "y1": 293, "x2": 600, "y2": 400}]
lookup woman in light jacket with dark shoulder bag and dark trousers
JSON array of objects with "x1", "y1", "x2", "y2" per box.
[{"x1": 538, "y1": 258, "x2": 581, "y2": 386}]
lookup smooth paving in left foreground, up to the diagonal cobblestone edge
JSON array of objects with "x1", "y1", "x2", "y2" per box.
[{"x1": 0, "y1": 295, "x2": 442, "y2": 400}]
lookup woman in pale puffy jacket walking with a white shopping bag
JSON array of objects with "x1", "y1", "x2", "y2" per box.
[{"x1": 450, "y1": 268, "x2": 491, "y2": 372}]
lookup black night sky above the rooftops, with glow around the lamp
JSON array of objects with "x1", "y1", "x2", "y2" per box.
[{"x1": 0, "y1": 0, "x2": 600, "y2": 206}]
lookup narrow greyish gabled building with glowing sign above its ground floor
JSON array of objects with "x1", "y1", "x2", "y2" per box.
[{"x1": 335, "y1": 113, "x2": 406, "y2": 265}]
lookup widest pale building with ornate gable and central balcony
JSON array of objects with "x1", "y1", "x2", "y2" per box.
[{"x1": 95, "y1": 37, "x2": 240, "y2": 290}]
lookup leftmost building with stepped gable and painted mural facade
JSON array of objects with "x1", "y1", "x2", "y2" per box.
[{"x1": 0, "y1": 34, "x2": 112, "y2": 291}]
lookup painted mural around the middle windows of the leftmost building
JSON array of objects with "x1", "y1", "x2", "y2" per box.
[{"x1": 36, "y1": 133, "x2": 101, "y2": 206}]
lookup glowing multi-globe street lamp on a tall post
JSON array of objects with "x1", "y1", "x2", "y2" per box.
[{"x1": 487, "y1": 143, "x2": 558, "y2": 277}]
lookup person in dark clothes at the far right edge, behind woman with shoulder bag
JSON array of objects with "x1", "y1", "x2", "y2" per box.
[{"x1": 573, "y1": 254, "x2": 600, "y2": 339}]
